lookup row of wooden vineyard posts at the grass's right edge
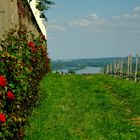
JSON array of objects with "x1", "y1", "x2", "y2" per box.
[{"x1": 101, "y1": 55, "x2": 140, "y2": 82}]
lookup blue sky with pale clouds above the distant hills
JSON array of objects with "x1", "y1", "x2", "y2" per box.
[{"x1": 46, "y1": 0, "x2": 140, "y2": 59}]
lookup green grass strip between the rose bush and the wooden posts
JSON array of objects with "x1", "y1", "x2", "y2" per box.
[{"x1": 24, "y1": 74, "x2": 140, "y2": 140}]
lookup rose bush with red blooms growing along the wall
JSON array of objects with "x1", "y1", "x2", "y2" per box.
[{"x1": 0, "y1": 28, "x2": 50, "y2": 139}]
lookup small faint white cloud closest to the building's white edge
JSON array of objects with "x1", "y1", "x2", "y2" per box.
[{"x1": 47, "y1": 20, "x2": 66, "y2": 32}]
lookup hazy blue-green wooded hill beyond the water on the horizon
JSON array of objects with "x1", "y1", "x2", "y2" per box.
[{"x1": 51, "y1": 57, "x2": 127, "y2": 70}]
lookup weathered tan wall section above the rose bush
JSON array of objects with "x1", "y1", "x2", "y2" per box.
[{"x1": 0, "y1": 0, "x2": 41, "y2": 37}]
